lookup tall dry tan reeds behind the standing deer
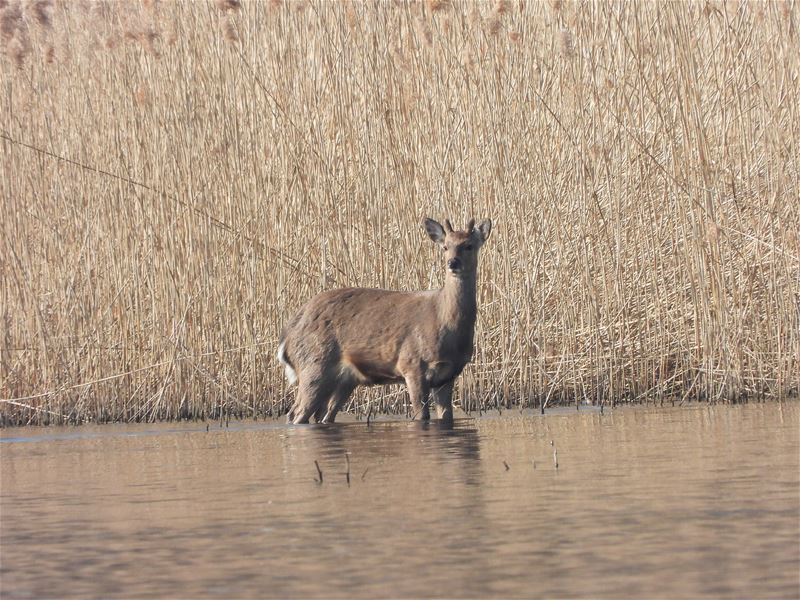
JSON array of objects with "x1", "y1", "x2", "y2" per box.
[{"x1": 0, "y1": 0, "x2": 800, "y2": 424}]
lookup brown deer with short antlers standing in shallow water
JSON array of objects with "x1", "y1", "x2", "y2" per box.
[{"x1": 278, "y1": 219, "x2": 492, "y2": 424}]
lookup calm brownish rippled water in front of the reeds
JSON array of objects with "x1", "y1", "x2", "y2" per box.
[{"x1": 0, "y1": 403, "x2": 800, "y2": 599}]
